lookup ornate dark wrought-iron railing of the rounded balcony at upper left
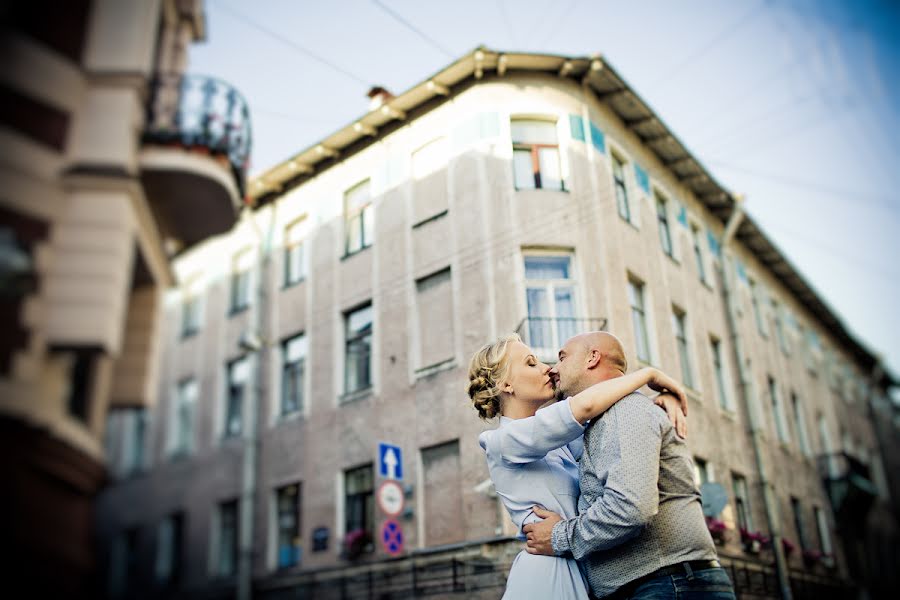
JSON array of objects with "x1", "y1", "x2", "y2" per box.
[{"x1": 143, "y1": 74, "x2": 251, "y2": 196}]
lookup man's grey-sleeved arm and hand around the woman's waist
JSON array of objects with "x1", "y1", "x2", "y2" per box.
[{"x1": 524, "y1": 397, "x2": 662, "y2": 559}]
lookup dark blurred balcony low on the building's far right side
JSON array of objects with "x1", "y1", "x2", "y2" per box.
[{"x1": 817, "y1": 452, "x2": 878, "y2": 528}]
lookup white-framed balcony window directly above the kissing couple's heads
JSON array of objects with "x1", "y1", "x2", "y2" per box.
[{"x1": 525, "y1": 254, "x2": 578, "y2": 362}]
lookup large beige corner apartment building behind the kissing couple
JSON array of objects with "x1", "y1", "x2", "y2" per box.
[{"x1": 98, "y1": 48, "x2": 898, "y2": 598}]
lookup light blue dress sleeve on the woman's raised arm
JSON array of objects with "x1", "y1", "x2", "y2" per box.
[{"x1": 491, "y1": 398, "x2": 584, "y2": 463}]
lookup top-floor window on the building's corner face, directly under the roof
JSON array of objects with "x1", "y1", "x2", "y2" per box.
[{"x1": 510, "y1": 119, "x2": 565, "y2": 190}]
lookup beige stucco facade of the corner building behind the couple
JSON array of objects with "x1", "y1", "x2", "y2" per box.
[{"x1": 95, "y1": 52, "x2": 897, "y2": 600}]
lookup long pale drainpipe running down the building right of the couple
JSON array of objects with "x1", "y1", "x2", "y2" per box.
[{"x1": 720, "y1": 195, "x2": 792, "y2": 600}]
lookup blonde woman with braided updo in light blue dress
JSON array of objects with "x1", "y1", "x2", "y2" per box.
[{"x1": 467, "y1": 335, "x2": 685, "y2": 600}]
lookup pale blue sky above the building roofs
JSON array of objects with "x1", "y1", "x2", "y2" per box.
[{"x1": 190, "y1": 0, "x2": 900, "y2": 376}]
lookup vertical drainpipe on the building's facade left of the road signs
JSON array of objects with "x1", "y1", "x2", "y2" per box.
[{"x1": 237, "y1": 204, "x2": 276, "y2": 600}]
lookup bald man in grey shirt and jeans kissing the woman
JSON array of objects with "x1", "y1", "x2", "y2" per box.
[{"x1": 524, "y1": 332, "x2": 735, "y2": 600}]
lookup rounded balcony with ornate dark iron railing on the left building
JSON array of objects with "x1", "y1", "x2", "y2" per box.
[{"x1": 140, "y1": 75, "x2": 251, "y2": 250}]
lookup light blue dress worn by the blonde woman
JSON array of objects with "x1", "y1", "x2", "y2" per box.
[{"x1": 478, "y1": 399, "x2": 588, "y2": 600}]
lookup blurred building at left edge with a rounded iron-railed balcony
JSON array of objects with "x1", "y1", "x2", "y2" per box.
[{"x1": 0, "y1": 0, "x2": 250, "y2": 598}]
